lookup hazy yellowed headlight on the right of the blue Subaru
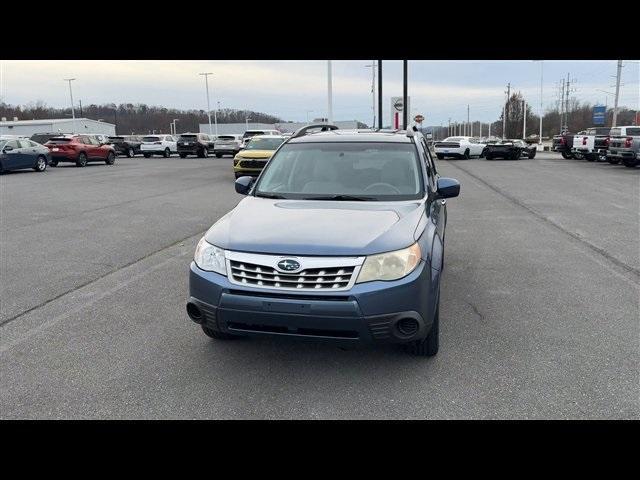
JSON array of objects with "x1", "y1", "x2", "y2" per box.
[{"x1": 356, "y1": 243, "x2": 422, "y2": 283}]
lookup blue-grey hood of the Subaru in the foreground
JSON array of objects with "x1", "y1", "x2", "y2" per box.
[{"x1": 206, "y1": 196, "x2": 425, "y2": 256}]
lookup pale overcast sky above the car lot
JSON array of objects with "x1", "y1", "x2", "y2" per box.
[{"x1": 0, "y1": 60, "x2": 640, "y2": 125}]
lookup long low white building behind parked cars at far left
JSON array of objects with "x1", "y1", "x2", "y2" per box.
[{"x1": 0, "y1": 118, "x2": 116, "y2": 137}]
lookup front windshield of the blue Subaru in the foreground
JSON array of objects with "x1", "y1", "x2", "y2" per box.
[{"x1": 255, "y1": 142, "x2": 423, "y2": 200}]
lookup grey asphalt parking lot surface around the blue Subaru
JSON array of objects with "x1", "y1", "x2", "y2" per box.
[{"x1": 0, "y1": 152, "x2": 640, "y2": 419}]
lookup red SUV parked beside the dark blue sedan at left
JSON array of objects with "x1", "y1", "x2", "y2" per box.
[{"x1": 45, "y1": 135, "x2": 116, "y2": 167}]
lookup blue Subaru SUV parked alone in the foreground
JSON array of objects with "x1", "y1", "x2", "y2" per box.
[{"x1": 187, "y1": 124, "x2": 460, "y2": 356}]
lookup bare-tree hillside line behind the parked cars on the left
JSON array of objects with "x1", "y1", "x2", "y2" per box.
[{"x1": 0, "y1": 101, "x2": 282, "y2": 135}]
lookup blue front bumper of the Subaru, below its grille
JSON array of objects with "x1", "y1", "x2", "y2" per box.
[{"x1": 188, "y1": 262, "x2": 438, "y2": 343}]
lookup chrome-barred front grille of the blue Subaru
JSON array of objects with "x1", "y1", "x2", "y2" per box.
[{"x1": 230, "y1": 261, "x2": 355, "y2": 290}]
